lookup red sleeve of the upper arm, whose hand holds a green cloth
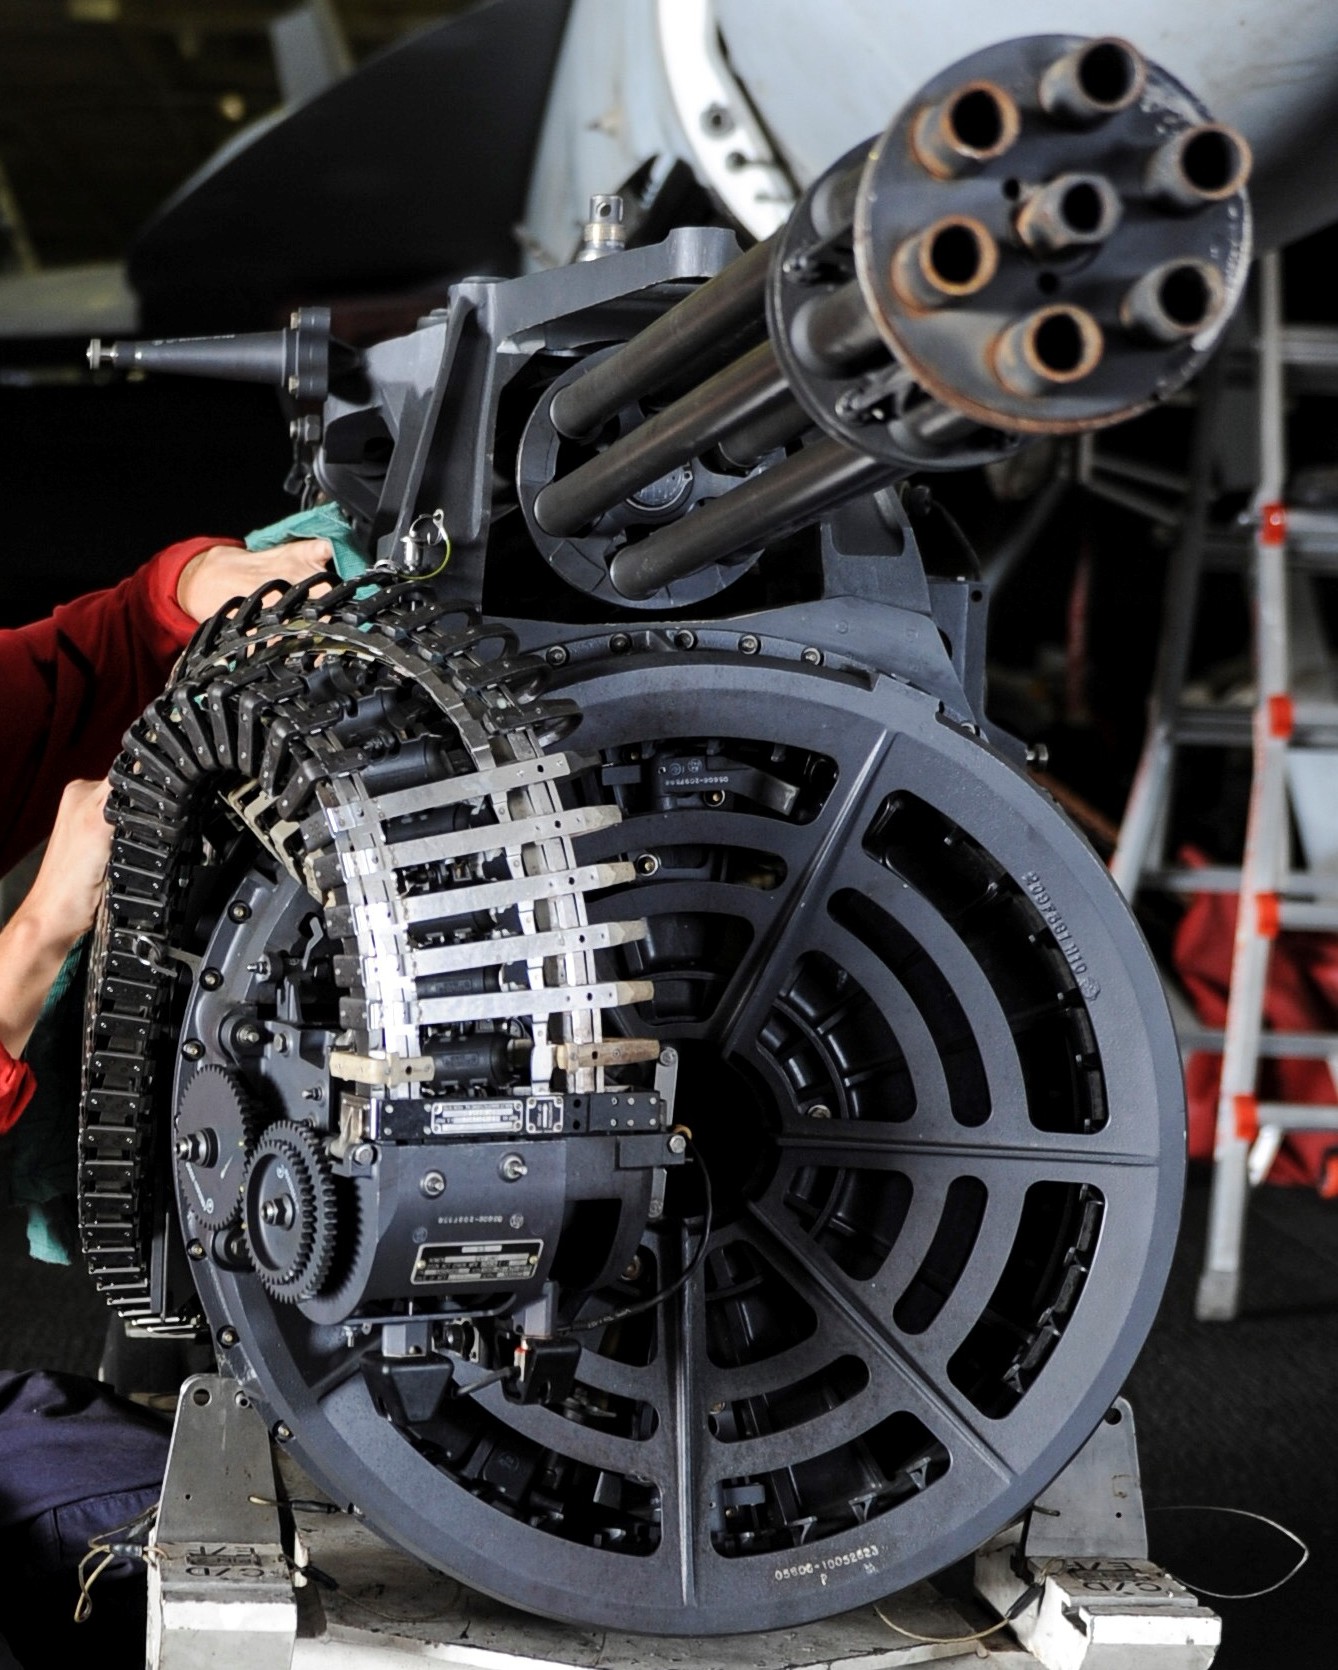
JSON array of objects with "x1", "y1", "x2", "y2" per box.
[{"x1": 0, "y1": 539, "x2": 239, "y2": 873}]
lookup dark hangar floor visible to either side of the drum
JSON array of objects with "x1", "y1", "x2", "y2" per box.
[{"x1": 0, "y1": 1172, "x2": 1338, "y2": 1670}]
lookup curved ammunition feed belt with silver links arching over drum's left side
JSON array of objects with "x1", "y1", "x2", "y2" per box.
[{"x1": 79, "y1": 576, "x2": 651, "y2": 1331}]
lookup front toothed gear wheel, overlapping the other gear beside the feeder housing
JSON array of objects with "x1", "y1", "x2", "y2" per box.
[{"x1": 242, "y1": 1121, "x2": 336, "y2": 1304}]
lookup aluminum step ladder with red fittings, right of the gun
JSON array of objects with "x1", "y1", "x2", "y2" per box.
[{"x1": 1111, "y1": 254, "x2": 1338, "y2": 1321}]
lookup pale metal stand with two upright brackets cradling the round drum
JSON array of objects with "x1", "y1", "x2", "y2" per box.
[{"x1": 147, "y1": 1374, "x2": 1221, "y2": 1670}]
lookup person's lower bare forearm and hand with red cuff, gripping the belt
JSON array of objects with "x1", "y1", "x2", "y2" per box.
[{"x1": 0, "y1": 780, "x2": 112, "y2": 1131}]
